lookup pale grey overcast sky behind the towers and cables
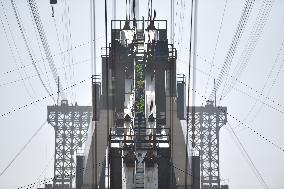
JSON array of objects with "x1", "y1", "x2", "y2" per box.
[{"x1": 0, "y1": 0, "x2": 284, "y2": 189}]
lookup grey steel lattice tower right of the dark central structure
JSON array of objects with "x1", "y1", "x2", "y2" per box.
[{"x1": 189, "y1": 101, "x2": 227, "y2": 189}]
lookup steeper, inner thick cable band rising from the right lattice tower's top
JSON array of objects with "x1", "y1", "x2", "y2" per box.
[{"x1": 209, "y1": 0, "x2": 255, "y2": 99}]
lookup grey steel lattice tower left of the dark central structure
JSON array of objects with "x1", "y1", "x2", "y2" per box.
[{"x1": 47, "y1": 100, "x2": 92, "y2": 188}]
